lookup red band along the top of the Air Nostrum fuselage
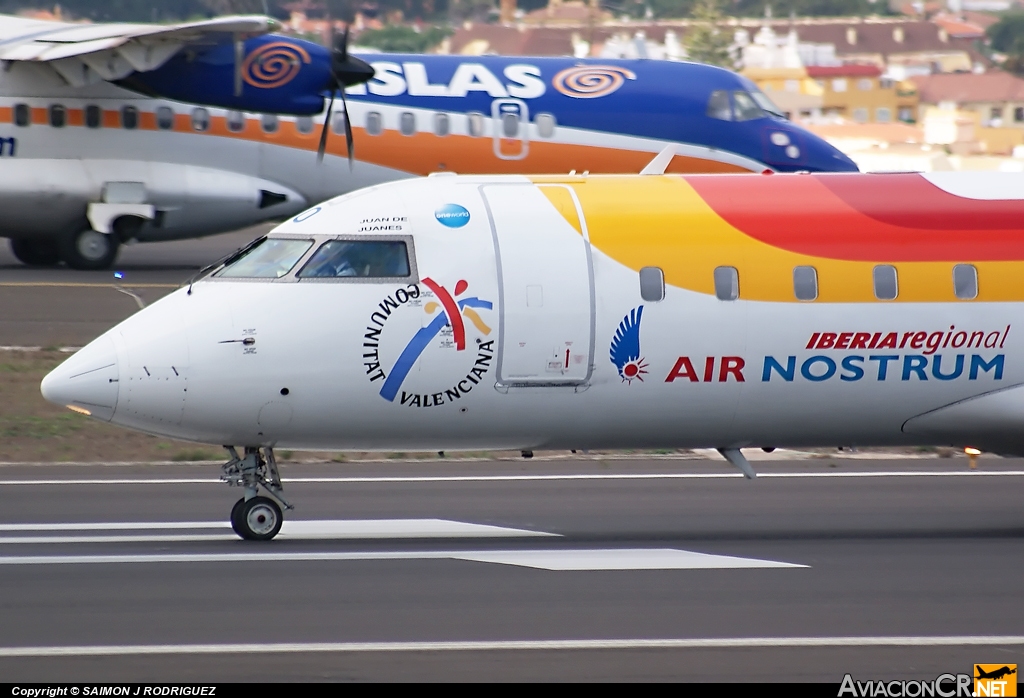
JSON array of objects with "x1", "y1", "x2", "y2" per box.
[{"x1": 687, "y1": 174, "x2": 1024, "y2": 262}]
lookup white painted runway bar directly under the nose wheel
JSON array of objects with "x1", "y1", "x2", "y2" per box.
[{"x1": 0, "y1": 519, "x2": 559, "y2": 544}]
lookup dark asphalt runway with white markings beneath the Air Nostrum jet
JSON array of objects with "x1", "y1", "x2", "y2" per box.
[{"x1": 0, "y1": 457, "x2": 1024, "y2": 684}]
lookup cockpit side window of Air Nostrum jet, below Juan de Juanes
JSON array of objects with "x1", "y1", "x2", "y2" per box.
[{"x1": 298, "y1": 239, "x2": 410, "y2": 278}]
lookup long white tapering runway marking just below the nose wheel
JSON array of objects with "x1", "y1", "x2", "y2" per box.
[{"x1": 0, "y1": 549, "x2": 807, "y2": 571}]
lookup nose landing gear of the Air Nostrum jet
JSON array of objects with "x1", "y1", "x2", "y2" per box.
[{"x1": 220, "y1": 446, "x2": 295, "y2": 540}]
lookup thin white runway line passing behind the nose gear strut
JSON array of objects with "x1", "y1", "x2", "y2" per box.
[{"x1": 0, "y1": 470, "x2": 1024, "y2": 486}]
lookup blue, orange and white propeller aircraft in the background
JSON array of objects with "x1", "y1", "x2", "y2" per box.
[{"x1": 0, "y1": 17, "x2": 856, "y2": 269}]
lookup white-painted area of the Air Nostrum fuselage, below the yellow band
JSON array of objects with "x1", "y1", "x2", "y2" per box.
[{"x1": 37, "y1": 175, "x2": 1024, "y2": 449}]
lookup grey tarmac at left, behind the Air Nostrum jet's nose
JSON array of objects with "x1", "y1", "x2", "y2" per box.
[{"x1": 0, "y1": 225, "x2": 272, "y2": 347}]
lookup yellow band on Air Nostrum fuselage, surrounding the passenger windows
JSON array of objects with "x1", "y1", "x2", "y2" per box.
[{"x1": 531, "y1": 175, "x2": 1024, "y2": 303}]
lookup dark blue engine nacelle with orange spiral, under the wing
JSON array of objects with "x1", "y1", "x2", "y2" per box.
[{"x1": 118, "y1": 34, "x2": 331, "y2": 116}]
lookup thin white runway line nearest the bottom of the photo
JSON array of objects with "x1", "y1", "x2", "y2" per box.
[{"x1": 0, "y1": 635, "x2": 1024, "y2": 658}]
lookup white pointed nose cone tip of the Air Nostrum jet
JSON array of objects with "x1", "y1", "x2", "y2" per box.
[{"x1": 39, "y1": 335, "x2": 119, "y2": 422}]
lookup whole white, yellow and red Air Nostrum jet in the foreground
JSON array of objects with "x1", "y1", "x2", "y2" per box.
[{"x1": 41, "y1": 166, "x2": 1024, "y2": 539}]
